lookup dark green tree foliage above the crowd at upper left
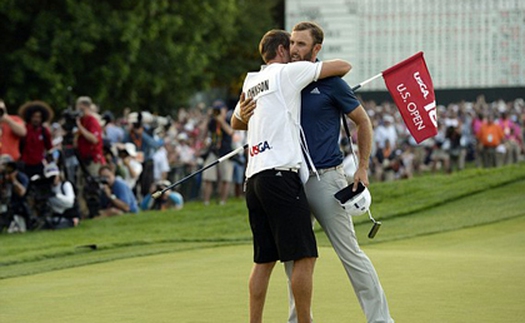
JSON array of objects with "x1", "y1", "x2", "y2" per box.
[{"x1": 0, "y1": 0, "x2": 279, "y2": 112}]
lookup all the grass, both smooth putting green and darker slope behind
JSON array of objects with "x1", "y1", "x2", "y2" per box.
[{"x1": 0, "y1": 164, "x2": 525, "y2": 323}]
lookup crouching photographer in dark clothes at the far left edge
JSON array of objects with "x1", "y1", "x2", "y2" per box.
[{"x1": 0, "y1": 154, "x2": 30, "y2": 232}]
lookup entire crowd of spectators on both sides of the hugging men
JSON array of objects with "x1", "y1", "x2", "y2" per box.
[{"x1": 0, "y1": 96, "x2": 525, "y2": 232}]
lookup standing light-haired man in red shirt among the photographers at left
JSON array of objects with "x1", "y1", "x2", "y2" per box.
[{"x1": 76, "y1": 96, "x2": 106, "y2": 216}]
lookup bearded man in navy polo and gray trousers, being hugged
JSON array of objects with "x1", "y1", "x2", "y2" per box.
[{"x1": 235, "y1": 22, "x2": 394, "y2": 323}]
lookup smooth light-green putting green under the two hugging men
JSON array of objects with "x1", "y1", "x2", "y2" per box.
[{"x1": 0, "y1": 217, "x2": 525, "y2": 323}]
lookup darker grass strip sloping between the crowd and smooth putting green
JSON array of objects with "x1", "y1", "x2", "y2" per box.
[{"x1": 0, "y1": 164, "x2": 525, "y2": 279}]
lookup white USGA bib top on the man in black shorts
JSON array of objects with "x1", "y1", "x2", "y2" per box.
[{"x1": 234, "y1": 62, "x2": 322, "y2": 178}]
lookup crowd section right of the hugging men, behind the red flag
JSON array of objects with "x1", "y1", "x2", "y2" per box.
[{"x1": 350, "y1": 95, "x2": 525, "y2": 181}]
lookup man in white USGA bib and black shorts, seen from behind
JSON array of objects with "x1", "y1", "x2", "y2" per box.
[{"x1": 237, "y1": 30, "x2": 351, "y2": 323}]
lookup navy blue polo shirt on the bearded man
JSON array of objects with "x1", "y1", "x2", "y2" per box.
[{"x1": 301, "y1": 77, "x2": 360, "y2": 169}]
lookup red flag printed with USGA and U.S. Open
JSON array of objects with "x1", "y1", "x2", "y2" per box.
[{"x1": 383, "y1": 52, "x2": 437, "y2": 143}]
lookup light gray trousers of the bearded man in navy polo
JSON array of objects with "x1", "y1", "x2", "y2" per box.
[{"x1": 285, "y1": 167, "x2": 394, "y2": 323}]
